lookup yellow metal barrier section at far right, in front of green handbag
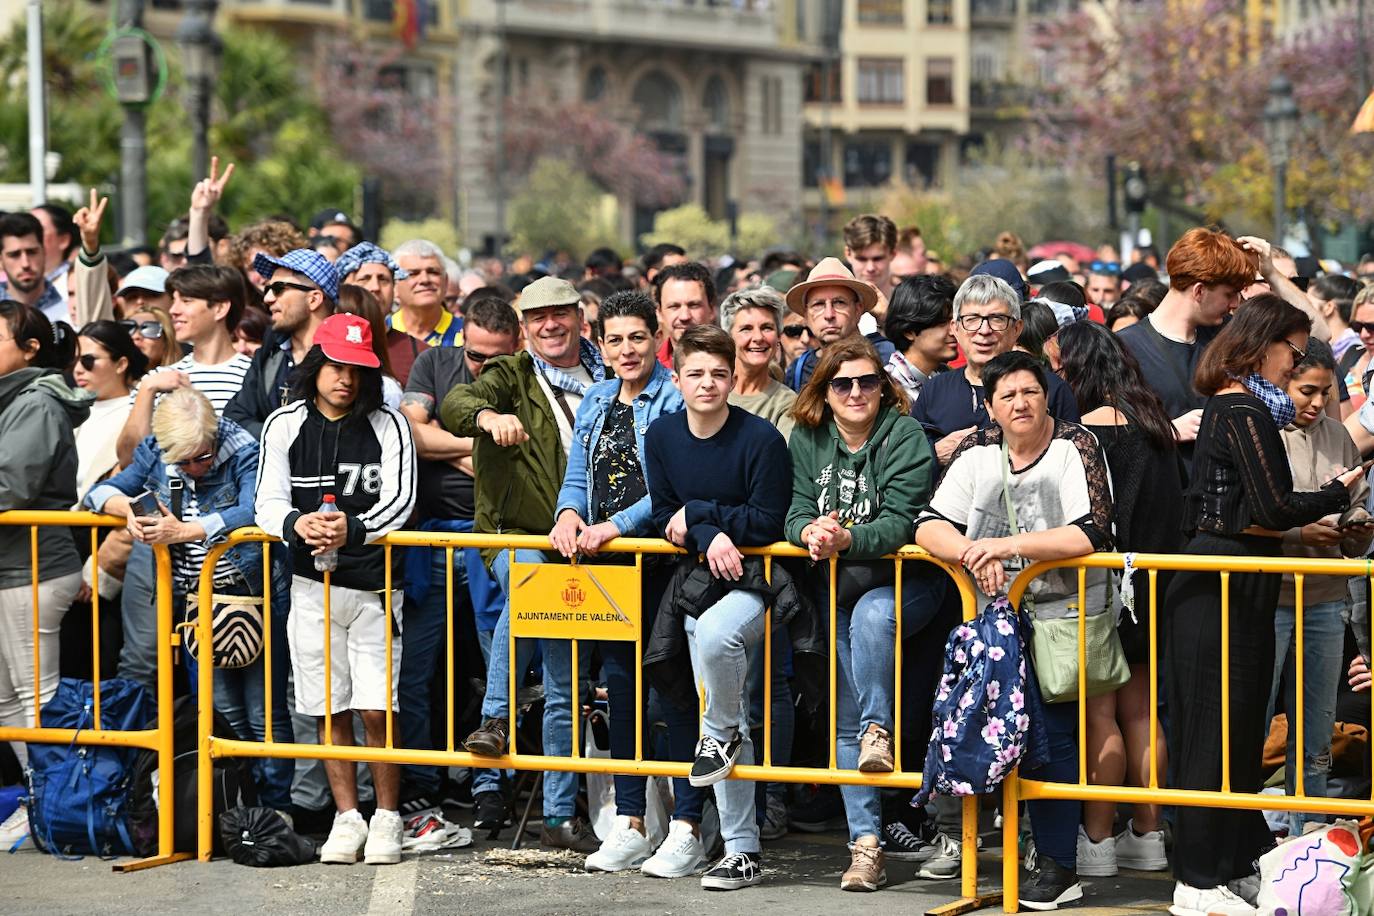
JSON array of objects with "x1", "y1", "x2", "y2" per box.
[{"x1": 1002, "y1": 553, "x2": 1374, "y2": 913}]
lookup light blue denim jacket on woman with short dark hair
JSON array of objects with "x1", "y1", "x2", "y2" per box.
[{"x1": 554, "y1": 364, "x2": 683, "y2": 537}]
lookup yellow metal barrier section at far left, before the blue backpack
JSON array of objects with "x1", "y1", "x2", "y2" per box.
[{"x1": 0, "y1": 509, "x2": 191, "y2": 872}]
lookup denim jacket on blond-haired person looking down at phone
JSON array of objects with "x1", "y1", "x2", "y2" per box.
[{"x1": 81, "y1": 419, "x2": 262, "y2": 595}]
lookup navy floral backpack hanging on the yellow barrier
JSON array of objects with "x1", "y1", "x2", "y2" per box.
[{"x1": 911, "y1": 596, "x2": 1048, "y2": 805}]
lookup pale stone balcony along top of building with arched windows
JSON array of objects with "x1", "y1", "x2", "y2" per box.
[{"x1": 467, "y1": 0, "x2": 778, "y2": 51}]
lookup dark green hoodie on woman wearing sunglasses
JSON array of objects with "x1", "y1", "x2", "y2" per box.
[{"x1": 787, "y1": 407, "x2": 934, "y2": 560}]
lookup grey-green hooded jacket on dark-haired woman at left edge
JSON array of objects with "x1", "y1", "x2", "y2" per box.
[{"x1": 0, "y1": 368, "x2": 91, "y2": 588}]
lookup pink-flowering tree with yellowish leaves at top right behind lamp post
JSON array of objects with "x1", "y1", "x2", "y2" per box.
[{"x1": 1033, "y1": 0, "x2": 1374, "y2": 240}]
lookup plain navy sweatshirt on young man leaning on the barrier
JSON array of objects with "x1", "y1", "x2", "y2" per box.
[{"x1": 644, "y1": 407, "x2": 791, "y2": 553}]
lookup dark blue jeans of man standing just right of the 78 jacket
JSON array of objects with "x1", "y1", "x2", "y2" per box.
[{"x1": 397, "y1": 549, "x2": 467, "y2": 798}]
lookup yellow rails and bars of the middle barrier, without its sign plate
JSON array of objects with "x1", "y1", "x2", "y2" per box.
[{"x1": 198, "y1": 529, "x2": 998, "y2": 915}]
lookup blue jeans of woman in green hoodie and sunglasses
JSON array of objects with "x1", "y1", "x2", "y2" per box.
[{"x1": 835, "y1": 577, "x2": 944, "y2": 840}]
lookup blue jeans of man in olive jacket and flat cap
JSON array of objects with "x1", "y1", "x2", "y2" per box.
[{"x1": 473, "y1": 549, "x2": 591, "y2": 817}]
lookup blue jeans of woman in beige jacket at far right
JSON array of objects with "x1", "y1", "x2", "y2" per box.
[{"x1": 1265, "y1": 599, "x2": 1349, "y2": 836}]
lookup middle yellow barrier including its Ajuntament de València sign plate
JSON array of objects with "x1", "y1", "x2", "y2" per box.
[{"x1": 198, "y1": 529, "x2": 998, "y2": 915}]
